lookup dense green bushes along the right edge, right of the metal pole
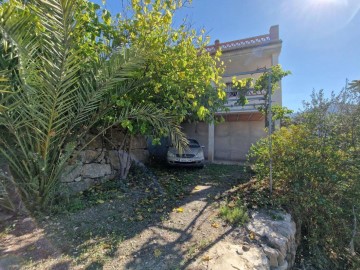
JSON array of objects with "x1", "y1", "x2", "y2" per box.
[{"x1": 249, "y1": 86, "x2": 360, "y2": 269}]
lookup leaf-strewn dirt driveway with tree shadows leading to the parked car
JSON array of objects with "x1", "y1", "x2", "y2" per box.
[{"x1": 0, "y1": 165, "x2": 249, "y2": 269}]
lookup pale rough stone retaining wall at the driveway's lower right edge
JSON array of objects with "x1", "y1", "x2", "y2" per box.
[{"x1": 189, "y1": 211, "x2": 296, "y2": 270}]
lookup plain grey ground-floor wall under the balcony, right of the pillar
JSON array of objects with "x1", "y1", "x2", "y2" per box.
[{"x1": 215, "y1": 120, "x2": 266, "y2": 161}]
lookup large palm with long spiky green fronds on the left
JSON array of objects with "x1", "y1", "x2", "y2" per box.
[{"x1": 0, "y1": 0, "x2": 185, "y2": 207}]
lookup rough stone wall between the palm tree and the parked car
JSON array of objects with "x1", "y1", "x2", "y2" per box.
[{"x1": 60, "y1": 130, "x2": 148, "y2": 193}]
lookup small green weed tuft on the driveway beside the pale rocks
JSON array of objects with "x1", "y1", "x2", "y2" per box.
[{"x1": 220, "y1": 199, "x2": 249, "y2": 225}]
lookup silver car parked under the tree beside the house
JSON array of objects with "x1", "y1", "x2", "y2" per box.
[{"x1": 166, "y1": 139, "x2": 205, "y2": 167}]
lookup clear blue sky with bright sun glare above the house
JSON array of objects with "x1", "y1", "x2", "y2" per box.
[{"x1": 97, "y1": 0, "x2": 360, "y2": 111}]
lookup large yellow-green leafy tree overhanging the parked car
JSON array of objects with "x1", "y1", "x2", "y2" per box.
[{"x1": 71, "y1": 0, "x2": 225, "y2": 177}]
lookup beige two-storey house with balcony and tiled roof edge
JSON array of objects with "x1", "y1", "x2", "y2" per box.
[{"x1": 183, "y1": 25, "x2": 282, "y2": 161}]
